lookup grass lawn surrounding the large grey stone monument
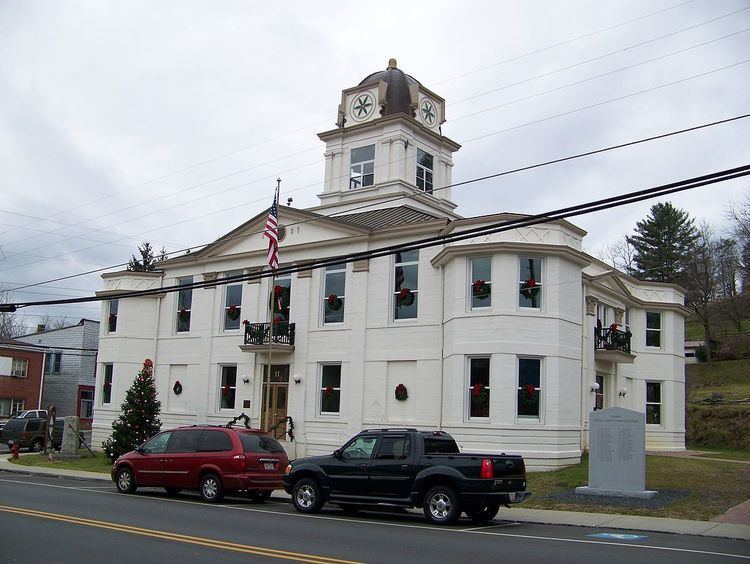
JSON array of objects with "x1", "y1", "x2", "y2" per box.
[{"x1": 521, "y1": 451, "x2": 750, "y2": 521}]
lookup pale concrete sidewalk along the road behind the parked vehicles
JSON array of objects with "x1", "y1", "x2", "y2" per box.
[{"x1": 0, "y1": 454, "x2": 750, "y2": 540}]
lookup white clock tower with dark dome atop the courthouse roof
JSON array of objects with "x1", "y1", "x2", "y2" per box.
[{"x1": 315, "y1": 59, "x2": 460, "y2": 218}]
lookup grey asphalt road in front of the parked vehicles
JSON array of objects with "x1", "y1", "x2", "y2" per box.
[{"x1": 0, "y1": 473, "x2": 750, "y2": 564}]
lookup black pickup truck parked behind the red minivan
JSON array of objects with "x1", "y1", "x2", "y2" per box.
[{"x1": 284, "y1": 429, "x2": 531, "y2": 525}]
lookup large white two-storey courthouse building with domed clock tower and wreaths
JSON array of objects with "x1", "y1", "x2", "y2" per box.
[{"x1": 94, "y1": 60, "x2": 686, "y2": 469}]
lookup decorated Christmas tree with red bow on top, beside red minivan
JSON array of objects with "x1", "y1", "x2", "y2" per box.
[{"x1": 102, "y1": 358, "x2": 161, "y2": 461}]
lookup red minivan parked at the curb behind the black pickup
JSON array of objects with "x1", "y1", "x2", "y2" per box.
[{"x1": 112, "y1": 425, "x2": 289, "y2": 503}]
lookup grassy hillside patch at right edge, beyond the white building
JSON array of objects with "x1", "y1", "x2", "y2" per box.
[{"x1": 685, "y1": 359, "x2": 750, "y2": 402}]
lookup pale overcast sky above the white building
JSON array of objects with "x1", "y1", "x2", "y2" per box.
[{"x1": 0, "y1": 0, "x2": 750, "y2": 328}]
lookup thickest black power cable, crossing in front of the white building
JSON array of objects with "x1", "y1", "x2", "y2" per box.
[{"x1": 0, "y1": 164, "x2": 750, "y2": 311}]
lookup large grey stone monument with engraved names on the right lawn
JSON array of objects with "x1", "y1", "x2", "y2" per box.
[{"x1": 576, "y1": 407, "x2": 658, "y2": 498}]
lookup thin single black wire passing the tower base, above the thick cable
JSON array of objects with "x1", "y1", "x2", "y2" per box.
[{"x1": 11, "y1": 113, "x2": 750, "y2": 291}]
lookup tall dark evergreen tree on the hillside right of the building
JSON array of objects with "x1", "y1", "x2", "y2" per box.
[{"x1": 627, "y1": 202, "x2": 698, "y2": 282}]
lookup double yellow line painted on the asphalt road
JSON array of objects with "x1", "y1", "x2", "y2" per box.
[{"x1": 0, "y1": 505, "x2": 356, "y2": 564}]
